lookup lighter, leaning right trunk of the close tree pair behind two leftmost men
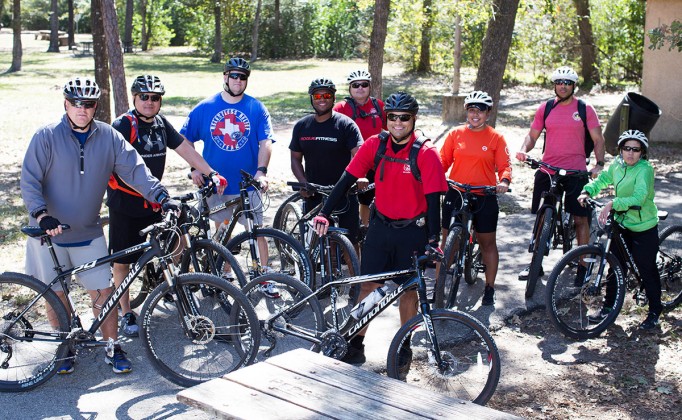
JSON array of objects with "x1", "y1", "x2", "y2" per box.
[{"x1": 101, "y1": 0, "x2": 128, "y2": 115}]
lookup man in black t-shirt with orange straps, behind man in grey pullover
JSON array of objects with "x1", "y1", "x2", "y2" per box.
[{"x1": 107, "y1": 75, "x2": 227, "y2": 337}]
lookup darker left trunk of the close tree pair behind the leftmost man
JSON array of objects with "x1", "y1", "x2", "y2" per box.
[{"x1": 90, "y1": 0, "x2": 111, "y2": 123}]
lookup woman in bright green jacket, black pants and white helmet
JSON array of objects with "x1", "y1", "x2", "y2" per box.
[{"x1": 578, "y1": 130, "x2": 662, "y2": 330}]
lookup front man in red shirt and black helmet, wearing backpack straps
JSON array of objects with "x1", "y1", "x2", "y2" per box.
[{"x1": 314, "y1": 92, "x2": 447, "y2": 370}]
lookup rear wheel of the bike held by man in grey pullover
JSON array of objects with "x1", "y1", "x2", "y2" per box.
[{"x1": 0, "y1": 272, "x2": 69, "y2": 392}]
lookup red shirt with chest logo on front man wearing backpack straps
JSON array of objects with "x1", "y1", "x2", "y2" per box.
[{"x1": 346, "y1": 133, "x2": 447, "y2": 220}]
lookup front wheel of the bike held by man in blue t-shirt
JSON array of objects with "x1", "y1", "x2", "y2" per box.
[{"x1": 225, "y1": 228, "x2": 313, "y2": 287}]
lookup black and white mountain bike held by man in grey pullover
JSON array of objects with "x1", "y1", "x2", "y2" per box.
[{"x1": 0, "y1": 212, "x2": 260, "y2": 392}]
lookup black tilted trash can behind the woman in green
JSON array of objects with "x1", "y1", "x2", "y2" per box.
[{"x1": 604, "y1": 92, "x2": 661, "y2": 156}]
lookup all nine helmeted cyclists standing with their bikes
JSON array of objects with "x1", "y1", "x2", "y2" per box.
[{"x1": 21, "y1": 58, "x2": 661, "y2": 373}]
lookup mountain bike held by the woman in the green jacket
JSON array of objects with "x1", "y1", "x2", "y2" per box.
[{"x1": 546, "y1": 199, "x2": 682, "y2": 339}]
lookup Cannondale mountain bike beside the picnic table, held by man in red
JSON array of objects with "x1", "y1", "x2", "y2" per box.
[{"x1": 243, "y1": 244, "x2": 500, "y2": 404}]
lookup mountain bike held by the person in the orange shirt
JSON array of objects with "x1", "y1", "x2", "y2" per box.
[{"x1": 433, "y1": 179, "x2": 504, "y2": 308}]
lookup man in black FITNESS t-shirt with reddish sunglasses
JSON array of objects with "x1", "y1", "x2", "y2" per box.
[{"x1": 289, "y1": 78, "x2": 362, "y2": 244}]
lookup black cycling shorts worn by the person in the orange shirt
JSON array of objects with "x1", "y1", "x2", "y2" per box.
[{"x1": 441, "y1": 188, "x2": 500, "y2": 233}]
